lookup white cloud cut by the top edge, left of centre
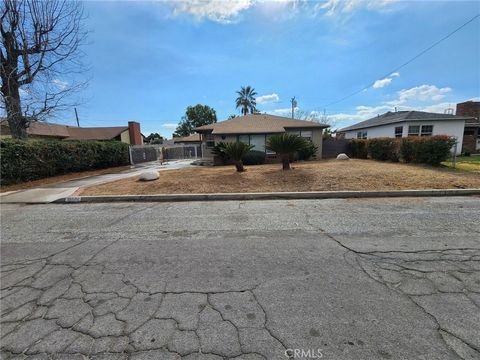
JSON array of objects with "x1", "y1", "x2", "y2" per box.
[{"x1": 173, "y1": 0, "x2": 254, "y2": 24}]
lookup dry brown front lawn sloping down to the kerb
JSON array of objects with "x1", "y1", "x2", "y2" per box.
[{"x1": 82, "y1": 159, "x2": 480, "y2": 195}]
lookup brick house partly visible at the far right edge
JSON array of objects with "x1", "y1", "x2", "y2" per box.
[{"x1": 457, "y1": 101, "x2": 480, "y2": 154}]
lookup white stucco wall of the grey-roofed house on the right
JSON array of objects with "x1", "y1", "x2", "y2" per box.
[{"x1": 345, "y1": 120, "x2": 465, "y2": 155}]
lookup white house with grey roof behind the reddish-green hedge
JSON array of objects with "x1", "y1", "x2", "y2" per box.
[{"x1": 337, "y1": 111, "x2": 475, "y2": 154}]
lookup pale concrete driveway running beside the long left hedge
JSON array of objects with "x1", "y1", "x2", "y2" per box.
[{"x1": 0, "y1": 160, "x2": 193, "y2": 204}]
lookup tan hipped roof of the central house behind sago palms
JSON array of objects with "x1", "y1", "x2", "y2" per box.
[{"x1": 194, "y1": 114, "x2": 329, "y2": 134}]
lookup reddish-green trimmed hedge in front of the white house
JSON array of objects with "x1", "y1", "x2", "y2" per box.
[{"x1": 349, "y1": 135, "x2": 455, "y2": 165}]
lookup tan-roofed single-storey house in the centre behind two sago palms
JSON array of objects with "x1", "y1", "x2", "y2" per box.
[{"x1": 194, "y1": 114, "x2": 329, "y2": 159}]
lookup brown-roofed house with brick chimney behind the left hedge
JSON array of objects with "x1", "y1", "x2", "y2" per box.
[{"x1": 0, "y1": 119, "x2": 143, "y2": 145}]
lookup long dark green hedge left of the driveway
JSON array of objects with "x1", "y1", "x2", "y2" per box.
[{"x1": 0, "y1": 139, "x2": 129, "y2": 185}]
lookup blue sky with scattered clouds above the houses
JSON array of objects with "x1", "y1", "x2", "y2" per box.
[{"x1": 57, "y1": 0, "x2": 480, "y2": 137}]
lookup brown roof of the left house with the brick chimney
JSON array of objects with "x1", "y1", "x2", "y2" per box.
[{"x1": 0, "y1": 119, "x2": 128, "y2": 140}]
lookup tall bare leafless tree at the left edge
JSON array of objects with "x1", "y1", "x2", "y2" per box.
[{"x1": 0, "y1": 0, "x2": 87, "y2": 138}]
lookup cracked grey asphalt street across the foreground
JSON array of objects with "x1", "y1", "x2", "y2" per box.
[{"x1": 1, "y1": 197, "x2": 480, "y2": 360}]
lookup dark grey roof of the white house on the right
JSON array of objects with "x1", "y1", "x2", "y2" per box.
[{"x1": 337, "y1": 111, "x2": 474, "y2": 132}]
